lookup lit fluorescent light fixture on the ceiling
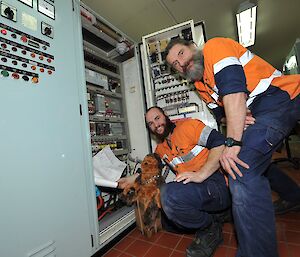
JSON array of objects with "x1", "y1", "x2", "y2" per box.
[{"x1": 236, "y1": 1, "x2": 257, "y2": 47}]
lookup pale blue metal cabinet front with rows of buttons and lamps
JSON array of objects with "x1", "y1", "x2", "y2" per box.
[{"x1": 0, "y1": 0, "x2": 98, "y2": 257}]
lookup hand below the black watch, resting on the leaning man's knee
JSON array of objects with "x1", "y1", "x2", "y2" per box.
[{"x1": 220, "y1": 146, "x2": 249, "y2": 180}]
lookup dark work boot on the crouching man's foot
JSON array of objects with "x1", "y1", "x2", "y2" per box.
[{"x1": 186, "y1": 221, "x2": 223, "y2": 257}]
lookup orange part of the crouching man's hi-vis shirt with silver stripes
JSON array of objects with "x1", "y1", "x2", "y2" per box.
[{"x1": 155, "y1": 119, "x2": 212, "y2": 173}]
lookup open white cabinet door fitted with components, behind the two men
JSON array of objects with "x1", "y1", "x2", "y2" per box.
[{"x1": 140, "y1": 20, "x2": 217, "y2": 152}]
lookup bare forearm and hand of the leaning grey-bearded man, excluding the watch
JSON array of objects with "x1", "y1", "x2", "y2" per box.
[{"x1": 220, "y1": 92, "x2": 249, "y2": 179}]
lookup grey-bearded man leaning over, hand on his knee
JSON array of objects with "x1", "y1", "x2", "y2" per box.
[{"x1": 166, "y1": 38, "x2": 300, "y2": 257}]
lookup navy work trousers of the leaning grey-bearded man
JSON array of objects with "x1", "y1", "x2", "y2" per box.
[{"x1": 229, "y1": 86, "x2": 300, "y2": 257}]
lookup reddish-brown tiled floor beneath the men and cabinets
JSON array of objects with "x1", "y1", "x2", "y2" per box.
[{"x1": 104, "y1": 142, "x2": 300, "y2": 257}]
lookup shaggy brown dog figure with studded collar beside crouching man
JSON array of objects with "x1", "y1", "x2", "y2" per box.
[{"x1": 121, "y1": 154, "x2": 164, "y2": 237}]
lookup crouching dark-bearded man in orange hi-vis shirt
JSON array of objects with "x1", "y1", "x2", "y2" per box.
[{"x1": 119, "y1": 106, "x2": 231, "y2": 257}]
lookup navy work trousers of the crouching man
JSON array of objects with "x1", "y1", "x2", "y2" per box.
[{"x1": 160, "y1": 172, "x2": 231, "y2": 229}]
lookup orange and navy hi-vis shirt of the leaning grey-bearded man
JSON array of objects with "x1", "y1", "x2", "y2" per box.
[{"x1": 195, "y1": 38, "x2": 300, "y2": 109}]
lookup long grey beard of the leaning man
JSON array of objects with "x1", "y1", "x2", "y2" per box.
[{"x1": 183, "y1": 50, "x2": 204, "y2": 81}]
